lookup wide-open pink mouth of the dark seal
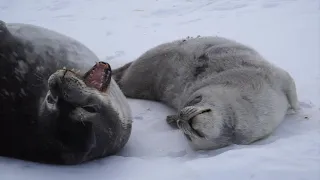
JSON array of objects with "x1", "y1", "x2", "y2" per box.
[{"x1": 83, "y1": 62, "x2": 111, "y2": 92}]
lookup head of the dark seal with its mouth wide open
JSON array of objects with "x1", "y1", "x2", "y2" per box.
[{"x1": 39, "y1": 62, "x2": 131, "y2": 164}]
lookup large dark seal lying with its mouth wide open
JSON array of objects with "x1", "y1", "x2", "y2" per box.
[{"x1": 0, "y1": 21, "x2": 132, "y2": 164}]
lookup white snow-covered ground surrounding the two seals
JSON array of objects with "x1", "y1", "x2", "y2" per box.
[{"x1": 0, "y1": 0, "x2": 320, "y2": 180}]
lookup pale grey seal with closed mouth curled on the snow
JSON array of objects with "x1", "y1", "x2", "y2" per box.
[{"x1": 113, "y1": 37, "x2": 298, "y2": 150}]
